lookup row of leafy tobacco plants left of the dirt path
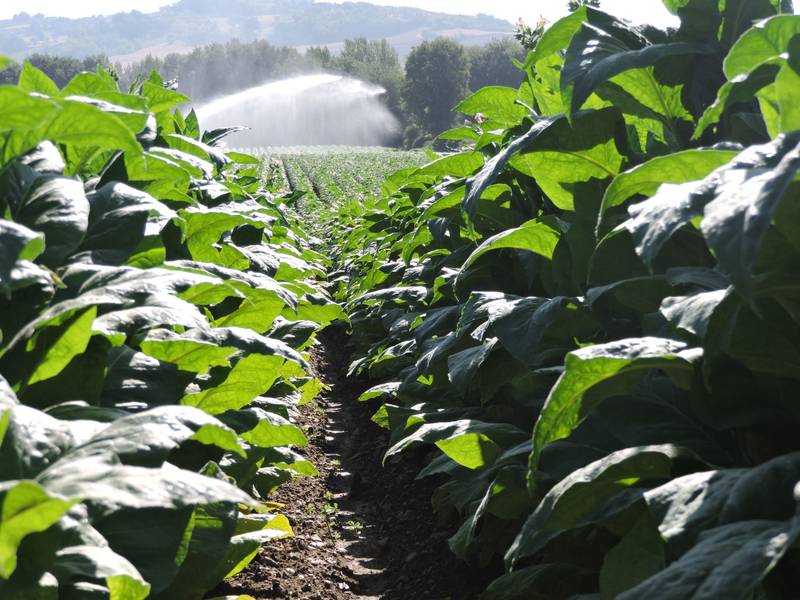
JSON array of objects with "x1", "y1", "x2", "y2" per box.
[{"x1": 0, "y1": 65, "x2": 341, "y2": 600}]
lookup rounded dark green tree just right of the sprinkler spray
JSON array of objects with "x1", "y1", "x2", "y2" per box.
[{"x1": 403, "y1": 38, "x2": 470, "y2": 145}]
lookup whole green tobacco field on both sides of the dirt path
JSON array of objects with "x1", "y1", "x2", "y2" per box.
[{"x1": 0, "y1": 0, "x2": 800, "y2": 600}]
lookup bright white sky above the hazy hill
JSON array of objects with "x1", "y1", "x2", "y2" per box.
[{"x1": 0, "y1": 0, "x2": 674, "y2": 25}]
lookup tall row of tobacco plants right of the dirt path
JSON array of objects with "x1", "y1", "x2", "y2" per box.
[{"x1": 333, "y1": 0, "x2": 800, "y2": 600}]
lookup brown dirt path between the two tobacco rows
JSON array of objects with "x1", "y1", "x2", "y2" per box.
[{"x1": 215, "y1": 329, "x2": 496, "y2": 600}]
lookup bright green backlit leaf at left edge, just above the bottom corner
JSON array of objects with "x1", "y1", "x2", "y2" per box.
[{"x1": 0, "y1": 481, "x2": 76, "y2": 579}]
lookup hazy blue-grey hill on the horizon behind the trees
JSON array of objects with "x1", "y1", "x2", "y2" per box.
[{"x1": 0, "y1": 0, "x2": 512, "y2": 62}]
